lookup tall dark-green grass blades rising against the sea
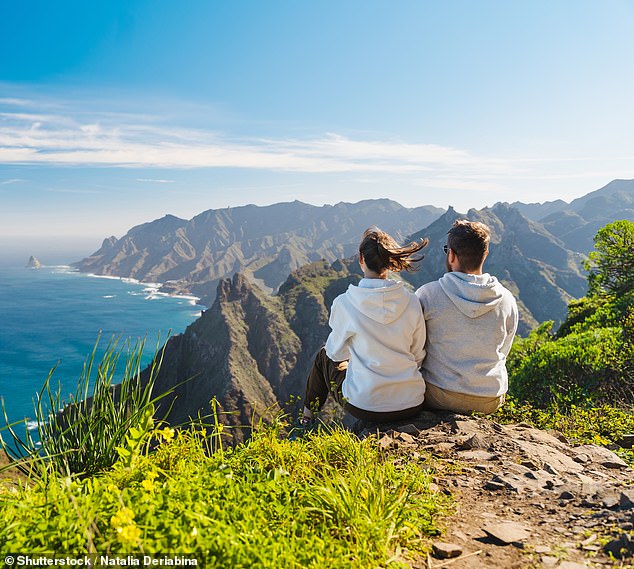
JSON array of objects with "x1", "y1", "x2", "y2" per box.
[{"x1": 0, "y1": 340, "x2": 166, "y2": 476}]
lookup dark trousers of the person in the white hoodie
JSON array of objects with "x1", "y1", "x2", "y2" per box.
[{"x1": 304, "y1": 348, "x2": 423, "y2": 423}]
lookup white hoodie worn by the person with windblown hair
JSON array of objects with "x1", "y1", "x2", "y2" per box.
[{"x1": 326, "y1": 279, "x2": 425, "y2": 412}]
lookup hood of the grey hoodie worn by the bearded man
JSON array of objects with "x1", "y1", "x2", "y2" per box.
[{"x1": 438, "y1": 272, "x2": 505, "y2": 318}]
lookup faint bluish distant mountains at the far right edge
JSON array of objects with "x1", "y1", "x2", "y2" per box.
[{"x1": 504, "y1": 180, "x2": 634, "y2": 254}]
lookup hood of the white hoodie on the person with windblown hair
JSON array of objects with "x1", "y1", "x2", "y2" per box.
[{"x1": 346, "y1": 280, "x2": 410, "y2": 324}]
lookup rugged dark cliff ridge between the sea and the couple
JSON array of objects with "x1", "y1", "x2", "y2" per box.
[{"x1": 144, "y1": 261, "x2": 359, "y2": 441}]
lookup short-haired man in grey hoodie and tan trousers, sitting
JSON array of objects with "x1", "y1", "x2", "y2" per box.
[{"x1": 416, "y1": 220, "x2": 518, "y2": 413}]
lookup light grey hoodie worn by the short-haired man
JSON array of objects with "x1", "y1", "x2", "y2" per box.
[{"x1": 416, "y1": 272, "x2": 518, "y2": 397}]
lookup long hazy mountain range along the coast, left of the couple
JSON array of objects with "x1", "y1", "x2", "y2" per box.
[{"x1": 75, "y1": 199, "x2": 444, "y2": 305}]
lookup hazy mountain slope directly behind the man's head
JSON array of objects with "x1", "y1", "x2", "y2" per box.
[{"x1": 403, "y1": 204, "x2": 586, "y2": 333}]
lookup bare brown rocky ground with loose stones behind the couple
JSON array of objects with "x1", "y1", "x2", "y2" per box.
[{"x1": 350, "y1": 412, "x2": 634, "y2": 569}]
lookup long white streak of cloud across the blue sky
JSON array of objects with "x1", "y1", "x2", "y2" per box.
[{"x1": 0, "y1": 103, "x2": 510, "y2": 182}]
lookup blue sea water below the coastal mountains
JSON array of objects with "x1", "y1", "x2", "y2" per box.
[{"x1": 0, "y1": 266, "x2": 201, "y2": 426}]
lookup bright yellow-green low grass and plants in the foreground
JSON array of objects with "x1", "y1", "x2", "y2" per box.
[{"x1": 0, "y1": 425, "x2": 449, "y2": 568}]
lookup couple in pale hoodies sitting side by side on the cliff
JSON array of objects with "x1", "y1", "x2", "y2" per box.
[{"x1": 302, "y1": 220, "x2": 518, "y2": 424}]
